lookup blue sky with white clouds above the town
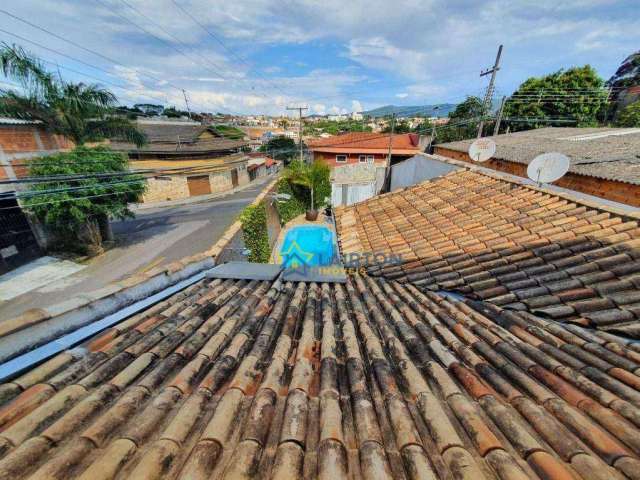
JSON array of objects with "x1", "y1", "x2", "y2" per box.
[{"x1": 0, "y1": 0, "x2": 640, "y2": 115}]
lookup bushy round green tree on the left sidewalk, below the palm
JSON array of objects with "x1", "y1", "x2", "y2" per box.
[{"x1": 19, "y1": 146, "x2": 145, "y2": 254}]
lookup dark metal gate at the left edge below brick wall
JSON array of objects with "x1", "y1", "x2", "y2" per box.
[{"x1": 0, "y1": 193, "x2": 42, "y2": 273}]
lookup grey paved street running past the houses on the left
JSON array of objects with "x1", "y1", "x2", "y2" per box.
[{"x1": 0, "y1": 177, "x2": 273, "y2": 321}]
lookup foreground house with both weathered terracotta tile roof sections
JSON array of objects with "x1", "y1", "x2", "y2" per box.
[{"x1": 6, "y1": 159, "x2": 640, "y2": 480}]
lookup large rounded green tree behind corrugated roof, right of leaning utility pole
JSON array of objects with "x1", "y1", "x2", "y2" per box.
[{"x1": 504, "y1": 65, "x2": 607, "y2": 130}]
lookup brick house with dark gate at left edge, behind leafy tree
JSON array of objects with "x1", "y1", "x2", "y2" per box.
[{"x1": 0, "y1": 118, "x2": 73, "y2": 274}]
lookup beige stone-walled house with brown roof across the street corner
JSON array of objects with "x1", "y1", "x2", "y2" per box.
[{"x1": 111, "y1": 122, "x2": 249, "y2": 202}]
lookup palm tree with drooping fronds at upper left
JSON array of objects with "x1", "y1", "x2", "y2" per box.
[{"x1": 0, "y1": 43, "x2": 146, "y2": 146}]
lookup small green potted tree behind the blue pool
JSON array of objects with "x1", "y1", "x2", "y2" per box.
[{"x1": 282, "y1": 160, "x2": 331, "y2": 210}]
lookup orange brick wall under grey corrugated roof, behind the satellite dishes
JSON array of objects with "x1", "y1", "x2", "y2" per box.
[{"x1": 434, "y1": 146, "x2": 640, "y2": 207}]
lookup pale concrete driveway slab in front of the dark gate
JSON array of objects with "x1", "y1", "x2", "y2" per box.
[{"x1": 0, "y1": 257, "x2": 86, "y2": 301}]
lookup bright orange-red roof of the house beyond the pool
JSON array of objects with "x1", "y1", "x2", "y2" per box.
[{"x1": 308, "y1": 132, "x2": 420, "y2": 153}]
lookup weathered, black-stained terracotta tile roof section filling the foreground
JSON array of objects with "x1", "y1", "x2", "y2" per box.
[{"x1": 0, "y1": 277, "x2": 640, "y2": 480}]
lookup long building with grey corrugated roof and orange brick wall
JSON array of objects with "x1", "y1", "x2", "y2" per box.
[{"x1": 434, "y1": 127, "x2": 640, "y2": 207}]
